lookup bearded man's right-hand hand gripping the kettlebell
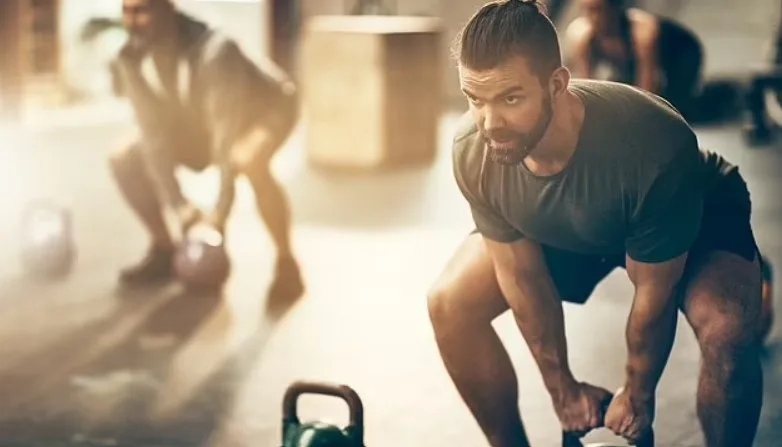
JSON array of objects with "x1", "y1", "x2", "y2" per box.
[{"x1": 605, "y1": 388, "x2": 654, "y2": 442}]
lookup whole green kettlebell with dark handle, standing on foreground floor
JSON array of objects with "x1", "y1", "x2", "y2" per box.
[{"x1": 282, "y1": 382, "x2": 364, "y2": 447}]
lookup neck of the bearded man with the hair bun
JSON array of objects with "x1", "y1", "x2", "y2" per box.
[{"x1": 525, "y1": 90, "x2": 585, "y2": 171}]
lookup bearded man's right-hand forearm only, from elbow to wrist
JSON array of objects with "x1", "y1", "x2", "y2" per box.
[{"x1": 625, "y1": 288, "x2": 677, "y2": 397}]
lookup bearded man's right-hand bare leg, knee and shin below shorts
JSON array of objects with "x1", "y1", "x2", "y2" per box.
[{"x1": 680, "y1": 251, "x2": 763, "y2": 447}]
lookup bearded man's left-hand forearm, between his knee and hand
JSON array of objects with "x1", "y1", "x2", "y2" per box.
[{"x1": 499, "y1": 274, "x2": 575, "y2": 396}]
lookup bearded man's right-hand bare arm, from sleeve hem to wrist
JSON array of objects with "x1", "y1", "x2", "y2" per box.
[{"x1": 625, "y1": 254, "x2": 687, "y2": 399}]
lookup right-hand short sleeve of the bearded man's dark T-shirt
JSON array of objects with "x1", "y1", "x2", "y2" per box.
[{"x1": 626, "y1": 142, "x2": 703, "y2": 263}]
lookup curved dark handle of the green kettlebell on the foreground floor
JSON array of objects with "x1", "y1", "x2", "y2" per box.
[{"x1": 282, "y1": 381, "x2": 364, "y2": 446}]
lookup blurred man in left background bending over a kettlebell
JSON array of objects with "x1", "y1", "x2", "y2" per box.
[{"x1": 110, "y1": 0, "x2": 303, "y2": 296}]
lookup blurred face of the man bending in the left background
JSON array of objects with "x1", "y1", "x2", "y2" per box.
[{"x1": 122, "y1": 0, "x2": 172, "y2": 47}]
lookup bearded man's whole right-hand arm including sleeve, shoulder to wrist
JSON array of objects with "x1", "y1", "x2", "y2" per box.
[{"x1": 626, "y1": 131, "x2": 703, "y2": 398}]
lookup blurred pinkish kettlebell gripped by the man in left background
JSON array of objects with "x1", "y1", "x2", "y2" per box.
[{"x1": 174, "y1": 225, "x2": 231, "y2": 289}]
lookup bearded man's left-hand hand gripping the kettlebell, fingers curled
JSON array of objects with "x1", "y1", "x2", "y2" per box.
[{"x1": 554, "y1": 382, "x2": 612, "y2": 437}]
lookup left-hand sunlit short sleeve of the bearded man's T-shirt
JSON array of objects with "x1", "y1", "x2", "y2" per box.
[{"x1": 454, "y1": 136, "x2": 524, "y2": 243}]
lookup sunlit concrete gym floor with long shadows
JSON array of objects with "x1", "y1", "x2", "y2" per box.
[{"x1": 0, "y1": 111, "x2": 782, "y2": 447}]
